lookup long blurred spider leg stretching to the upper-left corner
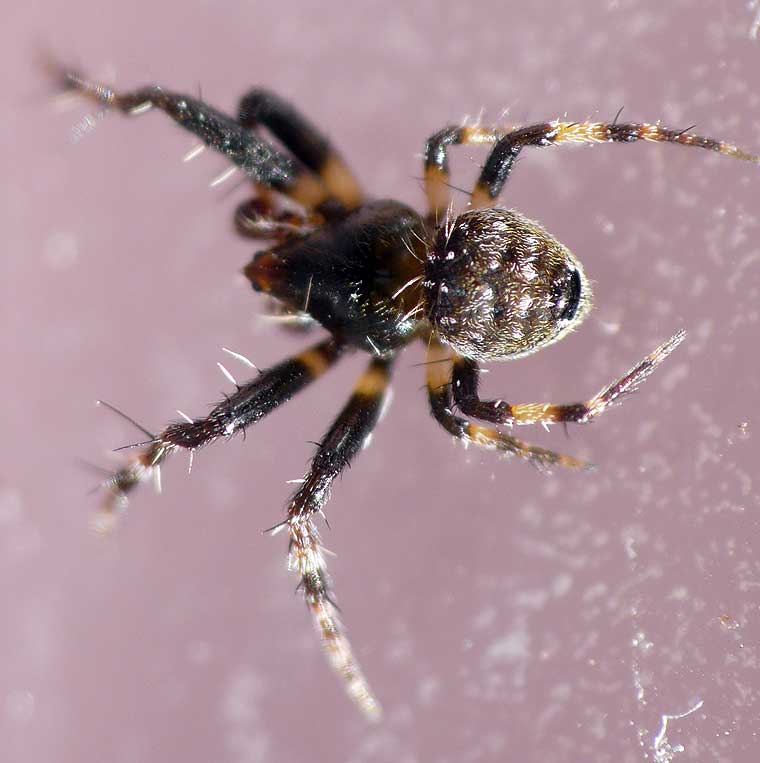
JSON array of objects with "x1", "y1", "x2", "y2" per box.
[{"x1": 58, "y1": 69, "x2": 332, "y2": 210}]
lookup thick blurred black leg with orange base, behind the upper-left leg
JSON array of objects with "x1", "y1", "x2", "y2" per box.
[{"x1": 238, "y1": 88, "x2": 363, "y2": 211}]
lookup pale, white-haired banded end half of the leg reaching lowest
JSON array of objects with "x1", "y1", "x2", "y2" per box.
[{"x1": 287, "y1": 516, "x2": 382, "y2": 721}]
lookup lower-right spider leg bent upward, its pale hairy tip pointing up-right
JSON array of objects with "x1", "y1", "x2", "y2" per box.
[{"x1": 452, "y1": 330, "x2": 686, "y2": 425}]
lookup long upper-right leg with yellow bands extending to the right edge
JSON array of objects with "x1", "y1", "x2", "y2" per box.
[{"x1": 472, "y1": 121, "x2": 760, "y2": 207}]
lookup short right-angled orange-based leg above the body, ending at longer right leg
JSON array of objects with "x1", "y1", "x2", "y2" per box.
[{"x1": 425, "y1": 125, "x2": 507, "y2": 221}]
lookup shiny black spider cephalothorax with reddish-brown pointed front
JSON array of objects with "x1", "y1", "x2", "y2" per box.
[{"x1": 244, "y1": 201, "x2": 427, "y2": 354}]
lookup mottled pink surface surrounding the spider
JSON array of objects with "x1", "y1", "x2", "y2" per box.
[{"x1": 0, "y1": 0, "x2": 760, "y2": 763}]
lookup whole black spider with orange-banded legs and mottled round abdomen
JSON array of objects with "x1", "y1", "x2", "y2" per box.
[{"x1": 56, "y1": 68, "x2": 760, "y2": 719}]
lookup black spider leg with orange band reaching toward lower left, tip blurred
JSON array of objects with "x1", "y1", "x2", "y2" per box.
[{"x1": 95, "y1": 339, "x2": 344, "y2": 532}]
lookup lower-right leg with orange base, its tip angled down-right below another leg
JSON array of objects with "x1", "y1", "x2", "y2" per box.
[{"x1": 426, "y1": 339, "x2": 591, "y2": 471}]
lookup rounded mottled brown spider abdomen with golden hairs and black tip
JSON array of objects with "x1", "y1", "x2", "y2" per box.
[{"x1": 423, "y1": 209, "x2": 591, "y2": 361}]
